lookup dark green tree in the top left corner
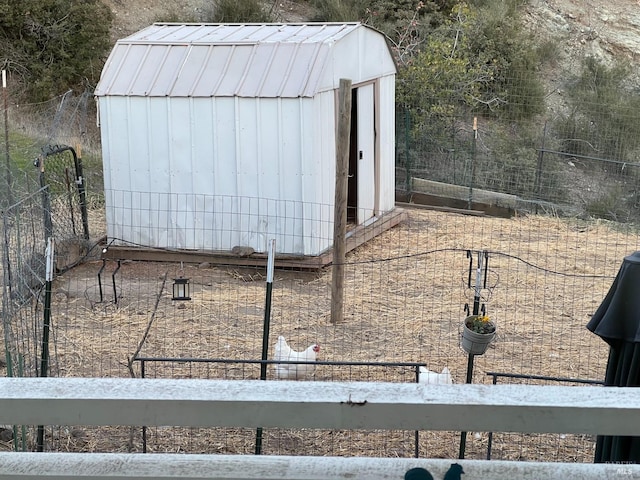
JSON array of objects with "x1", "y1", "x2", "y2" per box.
[{"x1": 0, "y1": 0, "x2": 111, "y2": 101}]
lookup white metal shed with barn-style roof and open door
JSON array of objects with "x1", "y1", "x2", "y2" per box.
[{"x1": 95, "y1": 23, "x2": 396, "y2": 255}]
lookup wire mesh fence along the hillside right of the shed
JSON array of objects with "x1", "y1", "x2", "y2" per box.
[{"x1": 396, "y1": 110, "x2": 640, "y2": 222}]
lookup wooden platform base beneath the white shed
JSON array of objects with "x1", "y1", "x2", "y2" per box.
[{"x1": 102, "y1": 208, "x2": 407, "y2": 270}]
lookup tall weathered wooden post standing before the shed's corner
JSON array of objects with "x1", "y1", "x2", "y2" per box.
[{"x1": 331, "y1": 78, "x2": 351, "y2": 324}]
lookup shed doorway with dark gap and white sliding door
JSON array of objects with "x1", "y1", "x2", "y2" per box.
[{"x1": 347, "y1": 84, "x2": 376, "y2": 225}]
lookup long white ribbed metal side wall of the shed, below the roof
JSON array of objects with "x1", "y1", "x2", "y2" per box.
[{"x1": 101, "y1": 94, "x2": 334, "y2": 255}]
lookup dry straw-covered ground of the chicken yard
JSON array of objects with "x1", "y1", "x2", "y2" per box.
[{"x1": 3, "y1": 210, "x2": 638, "y2": 461}]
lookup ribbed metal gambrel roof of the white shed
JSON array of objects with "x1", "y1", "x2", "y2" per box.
[{"x1": 95, "y1": 23, "x2": 395, "y2": 98}]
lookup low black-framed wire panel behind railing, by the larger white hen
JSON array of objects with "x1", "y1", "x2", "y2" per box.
[{"x1": 137, "y1": 357, "x2": 420, "y2": 457}]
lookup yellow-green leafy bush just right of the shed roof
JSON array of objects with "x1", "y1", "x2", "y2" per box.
[{"x1": 398, "y1": 0, "x2": 544, "y2": 127}]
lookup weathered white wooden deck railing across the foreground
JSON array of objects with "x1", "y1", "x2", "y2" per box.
[{"x1": 0, "y1": 378, "x2": 640, "y2": 480}]
